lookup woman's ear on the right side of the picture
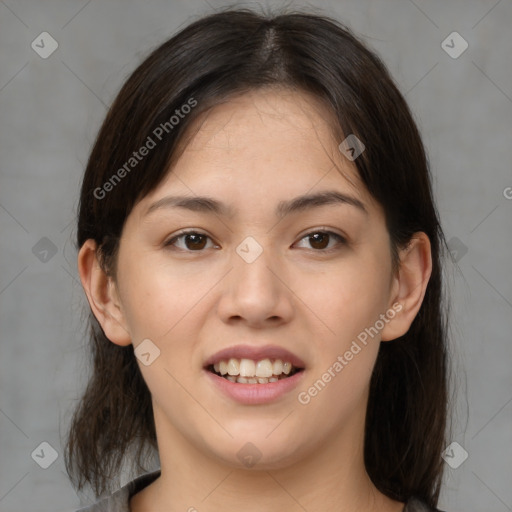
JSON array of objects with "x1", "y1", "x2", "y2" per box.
[{"x1": 381, "y1": 231, "x2": 432, "y2": 341}]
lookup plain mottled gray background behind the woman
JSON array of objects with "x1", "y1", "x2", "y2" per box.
[{"x1": 0, "y1": 0, "x2": 512, "y2": 512}]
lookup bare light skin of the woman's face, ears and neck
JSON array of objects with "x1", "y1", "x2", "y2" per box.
[{"x1": 78, "y1": 89, "x2": 432, "y2": 512}]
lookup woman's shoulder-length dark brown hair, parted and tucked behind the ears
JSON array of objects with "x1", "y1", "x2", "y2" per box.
[{"x1": 65, "y1": 9, "x2": 447, "y2": 506}]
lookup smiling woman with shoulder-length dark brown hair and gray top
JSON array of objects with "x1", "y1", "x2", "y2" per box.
[{"x1": 66, "y1": 10, "x2": 447, "y2": 512}]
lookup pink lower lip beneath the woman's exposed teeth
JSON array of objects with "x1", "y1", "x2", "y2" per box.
[{"x1": 204, "y1": 370, "x2": 304, "y2": 405}]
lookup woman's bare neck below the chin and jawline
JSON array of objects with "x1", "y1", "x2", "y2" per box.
[{"x1": 131, "y1": 408, "x2": 403, "y2": 512}]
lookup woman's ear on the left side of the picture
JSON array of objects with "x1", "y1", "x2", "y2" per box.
[{"x1": 78, "y1": 239, "x2": 131, "y2": 346}]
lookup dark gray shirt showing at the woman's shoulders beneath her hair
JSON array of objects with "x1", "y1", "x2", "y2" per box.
[{"x1": 76, "y1": 469, "x2": 441, "y2": 512}]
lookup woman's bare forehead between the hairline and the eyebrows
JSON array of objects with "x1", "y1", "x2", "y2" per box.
[{"x1": 138, "y1": 88, "x2": 378, "y2": 216}]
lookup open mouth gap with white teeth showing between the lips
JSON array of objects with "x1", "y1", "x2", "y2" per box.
[{"x1": 206, "y1": 357, "x2": 304, "y2": 384}]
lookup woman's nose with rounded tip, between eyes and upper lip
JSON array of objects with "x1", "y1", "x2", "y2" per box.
[{"x1": 218, "y1": 240, "x2": 294, "y2": 328}]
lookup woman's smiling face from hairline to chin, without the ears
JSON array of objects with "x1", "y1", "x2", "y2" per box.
[{"x1": 110, "y1": 90, "x2": 394, "y2": 468}]
